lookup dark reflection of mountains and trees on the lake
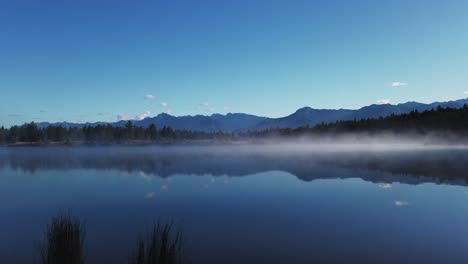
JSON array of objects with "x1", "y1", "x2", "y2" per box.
[{"x1": 0, "y1": 147, "x2": 468, "y2": 185}]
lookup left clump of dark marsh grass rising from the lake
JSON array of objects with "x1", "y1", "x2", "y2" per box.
[{"x1": 39, "y1": 213, "x2": 85, "y2": 264}]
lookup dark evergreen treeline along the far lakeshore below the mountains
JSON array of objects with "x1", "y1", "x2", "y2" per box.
[{"x1": 0, "y1": 104, "x2": 468, "y2": 144}]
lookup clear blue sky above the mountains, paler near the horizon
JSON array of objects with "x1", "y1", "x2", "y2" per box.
[{"x1": 0, "y1": 0, "x2": 468, "y2": 126}]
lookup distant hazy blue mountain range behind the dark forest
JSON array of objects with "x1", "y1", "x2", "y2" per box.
[{"x1": 38, "y1": 98, "x2": 468, "y2": 133}]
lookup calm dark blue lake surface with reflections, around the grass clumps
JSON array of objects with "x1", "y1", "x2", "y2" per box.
[{"x1": 0, "y1": 147, "x2": 468, "y2": 264}]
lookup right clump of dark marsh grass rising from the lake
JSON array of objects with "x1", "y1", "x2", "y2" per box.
[{"x1": 129, "y1": 221, "x2": 183, "y2": 264}]
